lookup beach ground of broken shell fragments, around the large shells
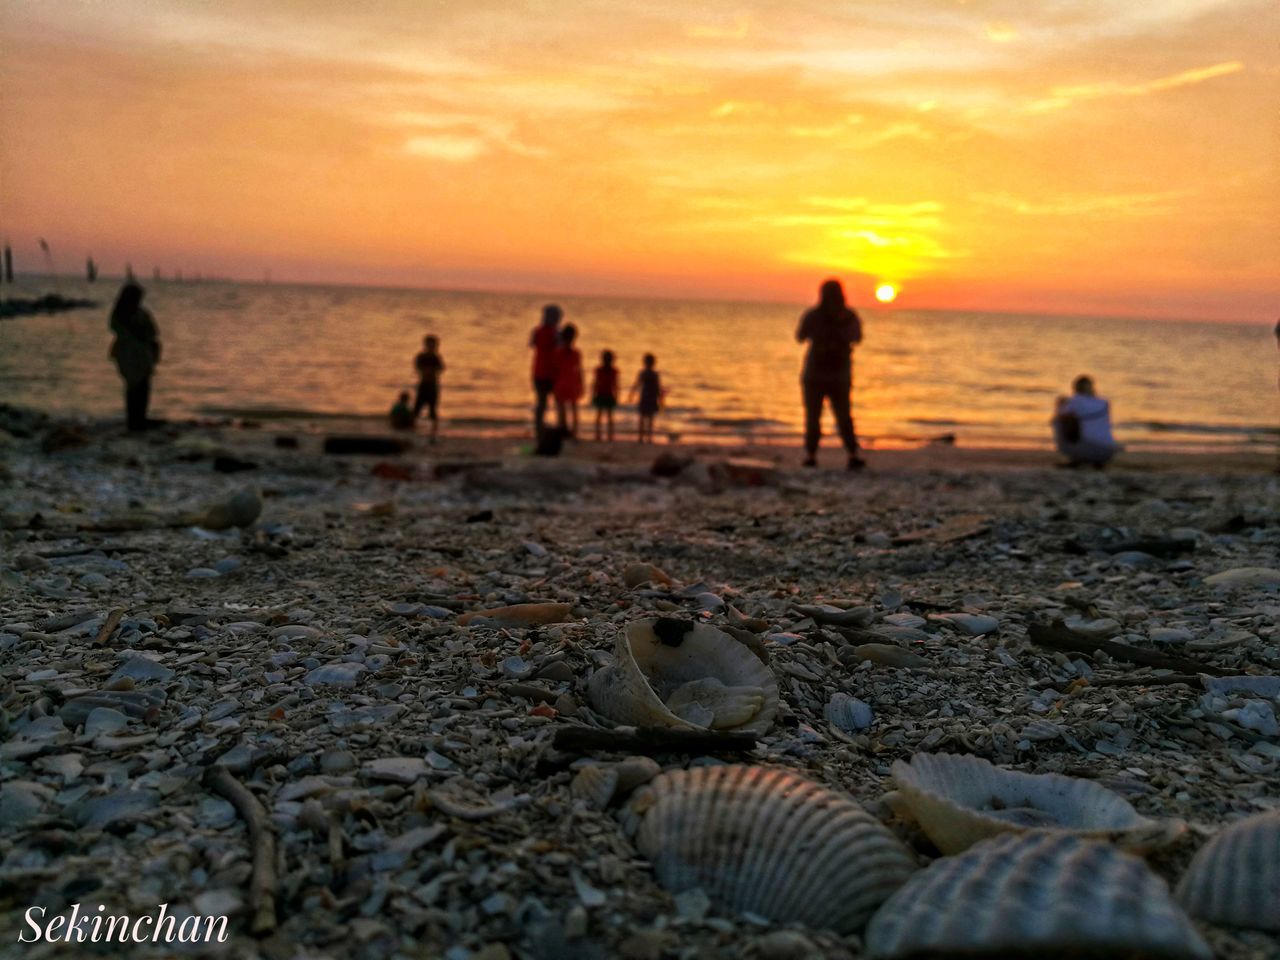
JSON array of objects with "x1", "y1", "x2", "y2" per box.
[{"x1": 0, "y1": 408, "x2": 1280, "y2": 960}]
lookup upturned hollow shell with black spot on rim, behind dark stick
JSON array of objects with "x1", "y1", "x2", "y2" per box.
[{"x1": 588, "y1": 618, "x2": 778, "y2": 732}]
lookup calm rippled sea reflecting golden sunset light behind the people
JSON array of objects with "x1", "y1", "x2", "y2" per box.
[{"x1": 0, "y1": 278, "x2": 1280, "y2": 449}]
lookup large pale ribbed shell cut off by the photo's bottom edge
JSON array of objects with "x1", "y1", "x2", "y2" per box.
[{"x1": 865, "y1": 832, "x2": 1212, "y2": 960}]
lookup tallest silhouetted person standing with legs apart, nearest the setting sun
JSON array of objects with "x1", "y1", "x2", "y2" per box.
[{"x1": 796, "y1": 280, "x2": 867, "y2": 470}]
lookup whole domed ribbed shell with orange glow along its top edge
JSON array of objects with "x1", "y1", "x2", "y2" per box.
[{"x1": 623, "y1": 765, "x2": 915, "y2": 933}]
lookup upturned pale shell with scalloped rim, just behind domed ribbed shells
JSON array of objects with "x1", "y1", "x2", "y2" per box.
[{"x1": 892, "y1": 754, "x2": 1185, "y2": 854}]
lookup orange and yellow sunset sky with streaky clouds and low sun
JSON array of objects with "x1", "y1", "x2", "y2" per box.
[{"x1": 0, "y1": 0, "x2": 1280, "y2": 321}]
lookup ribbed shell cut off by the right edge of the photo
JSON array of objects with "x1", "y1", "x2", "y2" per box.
[{"x1": 1178, "y1": 810, "x2": 1280, "y2": 931}]
